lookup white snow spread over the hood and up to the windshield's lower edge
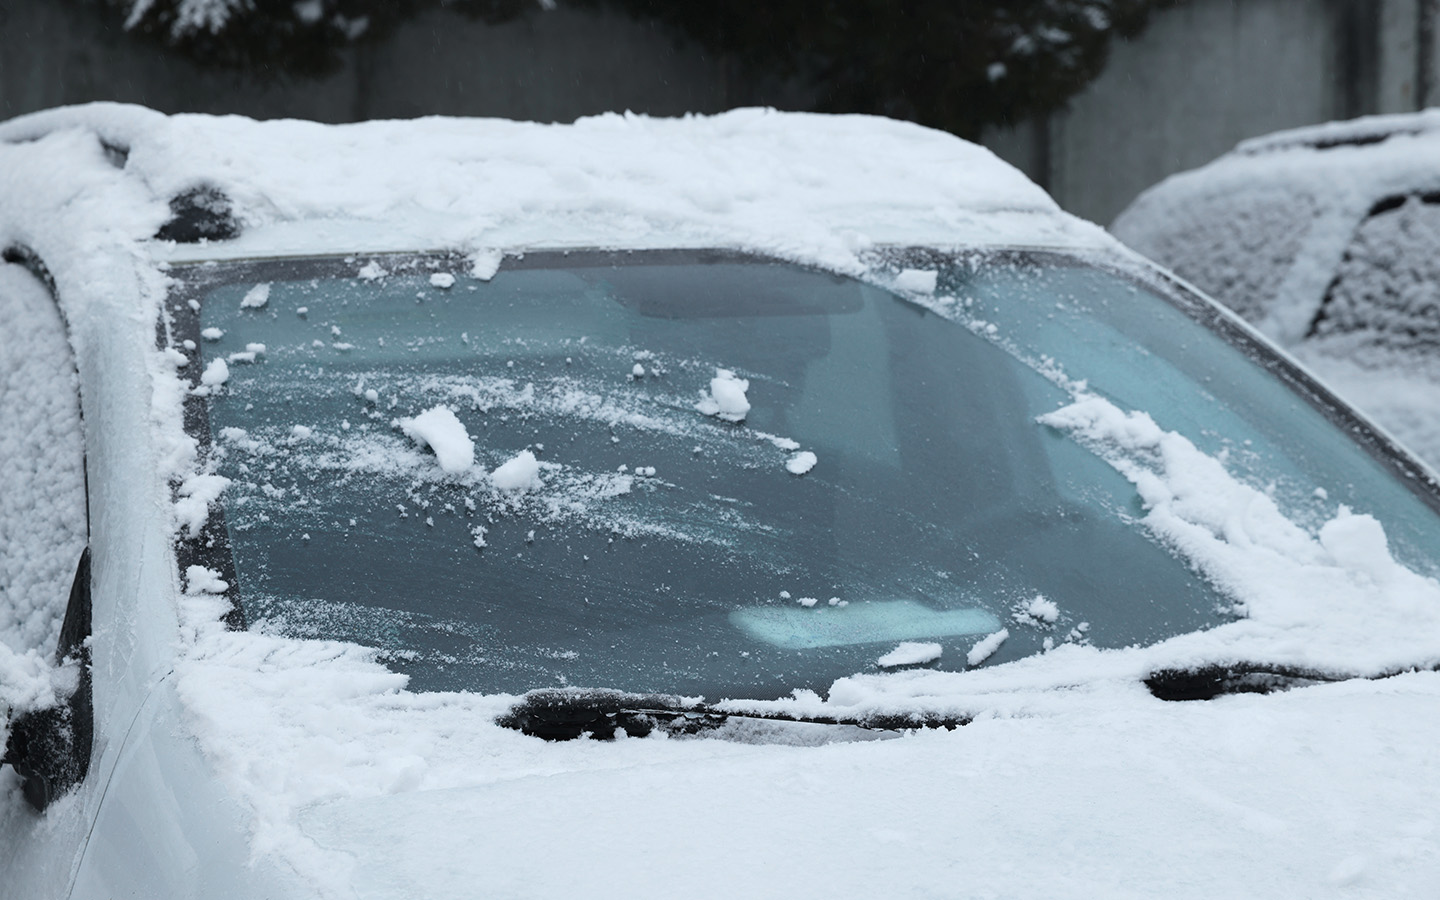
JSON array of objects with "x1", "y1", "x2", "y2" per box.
[{"x1": 177, "y1": 573, "x2": 1440, "y2": 899}]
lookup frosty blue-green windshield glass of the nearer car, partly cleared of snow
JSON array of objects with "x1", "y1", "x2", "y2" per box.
[{"x1": 173, "y1": 251, "x2": 1434, "y2": 700}]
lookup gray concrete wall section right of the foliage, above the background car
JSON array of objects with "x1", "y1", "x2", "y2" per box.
[{"x1": 985, "y1": 0, "x2": 1440, "y2": 223}]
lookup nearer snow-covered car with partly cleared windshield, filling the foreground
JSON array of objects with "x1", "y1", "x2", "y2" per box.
[{"x1": 8, "y1": 105, "x2": 1440, "y2": 899}]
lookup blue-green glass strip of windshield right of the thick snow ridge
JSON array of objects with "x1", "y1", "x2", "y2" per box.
[{"x1": 940, "y1": 259, "x2": 1440, "y2": 575}]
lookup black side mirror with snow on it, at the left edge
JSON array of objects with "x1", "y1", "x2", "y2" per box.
[{"x1": 0, "y1": 547, "x2": 95, "y2": 811}]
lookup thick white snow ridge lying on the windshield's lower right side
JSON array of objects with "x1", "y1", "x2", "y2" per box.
[{"x1": 1041, "y1": 395, "x2": 1440, "y2": 672}]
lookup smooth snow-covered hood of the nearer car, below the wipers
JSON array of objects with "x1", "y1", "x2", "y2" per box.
[{"x1": 300, "y1": 674, "x2": 1440, "y2": 900}]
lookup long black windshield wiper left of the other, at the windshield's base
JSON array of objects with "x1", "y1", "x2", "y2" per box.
[{"x1": 495, "y1": 688, "x2": 971, "y2": 740}]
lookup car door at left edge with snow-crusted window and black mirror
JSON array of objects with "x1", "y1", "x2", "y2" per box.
[{"x1": 0, "y1": 253, "x2": 91, "y2": 897}]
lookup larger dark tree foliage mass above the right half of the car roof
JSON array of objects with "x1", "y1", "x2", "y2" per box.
[{"x1": 570, "y1": 0, "x2": 1178, "y2": 138}]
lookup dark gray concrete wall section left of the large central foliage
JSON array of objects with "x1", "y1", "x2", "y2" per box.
[{"x1": 0, "y1": 0, "x2": 739, "y2": 121}]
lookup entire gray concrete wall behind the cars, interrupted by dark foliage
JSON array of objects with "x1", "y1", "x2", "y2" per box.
[{"x1": 0, "y1": 0, "x2": 1440, "y2": 223}]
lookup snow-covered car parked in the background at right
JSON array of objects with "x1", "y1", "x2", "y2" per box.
[{"x1": 1112, "y1": 109, "x2": 1440, "y2": 465}]
